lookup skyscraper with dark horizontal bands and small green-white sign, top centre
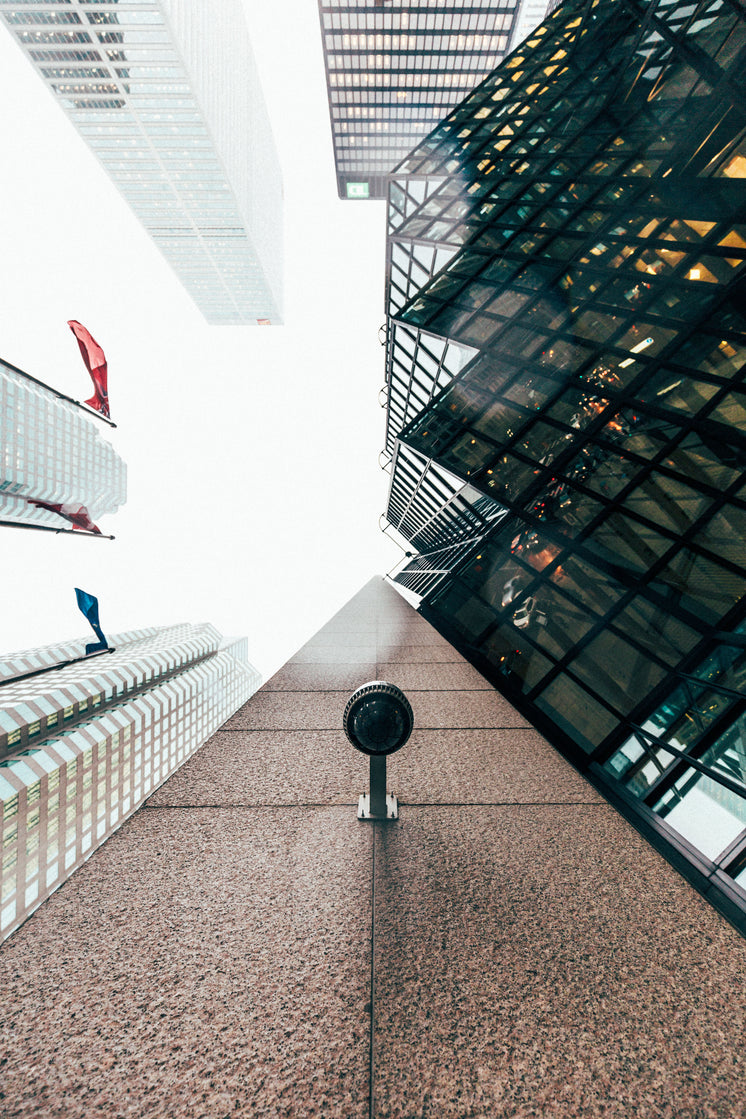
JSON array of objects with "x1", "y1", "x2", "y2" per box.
[{"x1": 319, "y1": 0, "x2": 553, "y2": 198}]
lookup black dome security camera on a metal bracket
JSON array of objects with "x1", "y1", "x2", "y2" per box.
[{"x1": 342, "y1": 680, "x2": 415, "y2": 820}]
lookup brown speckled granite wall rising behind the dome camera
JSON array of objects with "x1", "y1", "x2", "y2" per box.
[{"x1": 0, "y1": 580, "x2": 746, "y2": 1119}]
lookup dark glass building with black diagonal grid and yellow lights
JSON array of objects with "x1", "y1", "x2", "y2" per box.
[{"x1": 387, "y1": 0, "x2": 746, "y2": 908}]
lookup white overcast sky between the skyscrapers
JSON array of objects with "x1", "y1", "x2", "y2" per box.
[{"x1": 0, "y1": 0, "x2": 409, "y2": 675}]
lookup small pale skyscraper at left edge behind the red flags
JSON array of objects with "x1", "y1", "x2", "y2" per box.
[{"x1": 0, "y1": 361, "x2": 126, "y2": 529}]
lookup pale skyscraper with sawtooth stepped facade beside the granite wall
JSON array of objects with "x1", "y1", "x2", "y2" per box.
[{"x1": 0, "y1": 624, "x2": 261, "y2": 939}]
